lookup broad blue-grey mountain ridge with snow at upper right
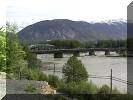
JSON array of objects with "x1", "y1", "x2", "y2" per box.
[{"x1": 18, "y1": 19, "x2": 127, "y2": 43}]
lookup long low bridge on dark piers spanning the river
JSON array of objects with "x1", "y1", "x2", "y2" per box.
[{"x1": 30, "y1": 48, "x2": 127, "y2": 58}]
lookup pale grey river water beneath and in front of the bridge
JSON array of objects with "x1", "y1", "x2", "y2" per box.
[{"x1": 37, "y1": 52, "x2": 127, "y2": 93}]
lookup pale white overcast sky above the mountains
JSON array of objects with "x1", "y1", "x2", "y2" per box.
[{"x1": 0, "y1": 0, "x2": 132, "y2": 27}]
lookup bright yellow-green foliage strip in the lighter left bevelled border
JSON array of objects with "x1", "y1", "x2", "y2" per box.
[{"x1": 0, "y1": 29, "x2": 6, "y2": 71}]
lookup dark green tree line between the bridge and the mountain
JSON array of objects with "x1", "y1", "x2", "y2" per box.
[{"x1": 42, "y1": 40, "x2": 127, "y2": 49}]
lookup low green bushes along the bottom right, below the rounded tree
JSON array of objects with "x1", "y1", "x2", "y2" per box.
[{"x1": 58, "y1": 80, "x2": 133, "y2": 100}]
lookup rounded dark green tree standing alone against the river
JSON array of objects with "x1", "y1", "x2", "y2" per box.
[{"x1": 62, "y1": 56, "x2": 88, "y2": 82}]
